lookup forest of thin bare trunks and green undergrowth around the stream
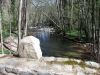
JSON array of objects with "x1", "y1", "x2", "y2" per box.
[{"x1": 0, "y1": 0, "x2": 100, "y2": 62}]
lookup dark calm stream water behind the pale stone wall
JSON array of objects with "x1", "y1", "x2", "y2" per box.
[{"x1": 34, "y1": 32, "x2": 93, "y2": 60}]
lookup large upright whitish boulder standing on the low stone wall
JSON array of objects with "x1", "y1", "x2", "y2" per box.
[{"x1": 18, "y1": 36, "x2": 42, "y2": 59}]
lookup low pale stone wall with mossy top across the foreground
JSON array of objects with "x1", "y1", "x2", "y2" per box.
[{"x1": 0, "y1": 55, "x2": 100, "y2": 75}]
